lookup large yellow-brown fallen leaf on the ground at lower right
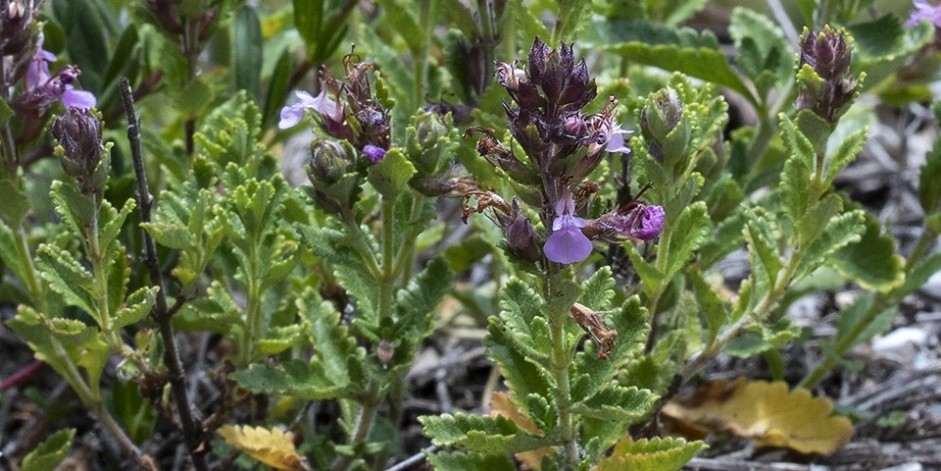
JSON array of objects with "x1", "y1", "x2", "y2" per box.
[{"x1": 663, "y1": 378, "x2": 853, "y2": 455}]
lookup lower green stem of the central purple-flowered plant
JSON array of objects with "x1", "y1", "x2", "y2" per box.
[{"x1": 543, "y1": 272, "x2": 579, "y2": 470}]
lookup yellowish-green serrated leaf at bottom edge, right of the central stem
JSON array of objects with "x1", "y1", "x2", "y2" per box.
[{"x1": 592, "y1": 437, "x2": 706, "y2": 471}]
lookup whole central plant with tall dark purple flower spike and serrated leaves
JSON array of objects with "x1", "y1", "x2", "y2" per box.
[{"x1": 421, "y1": 38, "x2": 702, "y2": 469}]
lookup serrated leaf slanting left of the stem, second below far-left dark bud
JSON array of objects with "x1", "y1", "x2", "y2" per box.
[{"x1": 36, "y1": 244, "x2": 98, "y2": 316}]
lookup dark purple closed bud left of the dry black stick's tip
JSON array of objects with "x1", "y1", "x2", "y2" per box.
[{"x1": 52, "y1": 108, "x2": 110, "y2": 192}]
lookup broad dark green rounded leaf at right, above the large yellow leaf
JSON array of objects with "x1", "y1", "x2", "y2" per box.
[{"x1": 827, "y1": 209, "x2": 905, "y2": 292}]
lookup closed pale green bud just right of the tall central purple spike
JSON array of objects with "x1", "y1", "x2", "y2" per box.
[{"x1": 640, "y1": 88, "x2": 690, "y2": 162}]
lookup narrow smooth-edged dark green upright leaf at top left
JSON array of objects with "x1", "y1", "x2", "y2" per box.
[{"x1": 233, "y1": 2, "x2": 262, "y2": 101}]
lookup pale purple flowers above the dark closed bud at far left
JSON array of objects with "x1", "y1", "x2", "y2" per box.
[{"x1": 25, "y1": 46, "x2": 97, "y2": 109}]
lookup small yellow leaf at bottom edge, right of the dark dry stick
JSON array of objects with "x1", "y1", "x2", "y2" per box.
[{"x1": 219, "y1": 425, "x2": 310, "y2": 471}]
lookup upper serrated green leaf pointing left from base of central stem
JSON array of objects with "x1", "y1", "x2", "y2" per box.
[{"x1": 418, "y1": 413, "x2": 546, "y2": 454}]
